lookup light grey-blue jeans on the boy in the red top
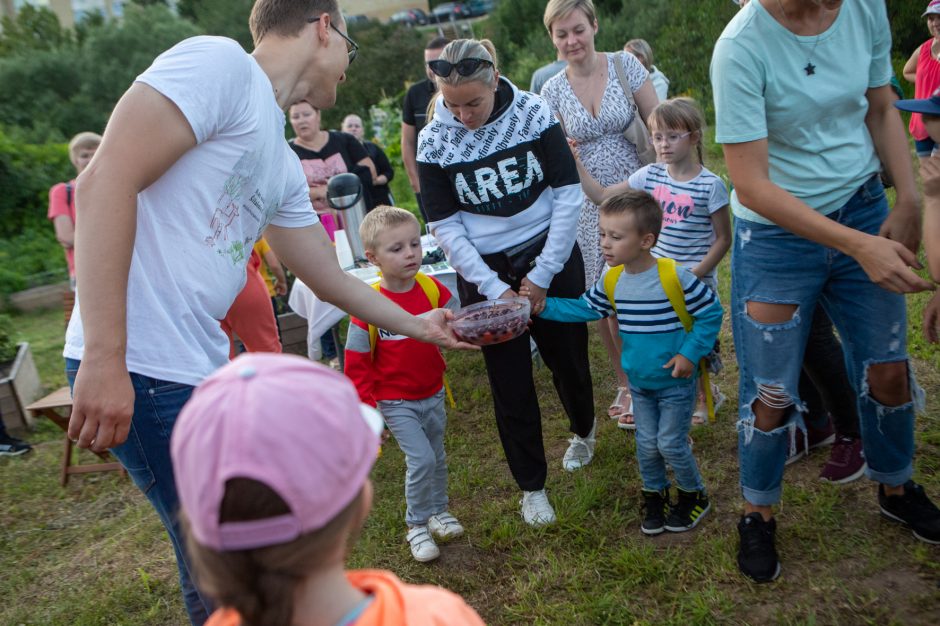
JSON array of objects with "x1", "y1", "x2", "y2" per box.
[{"x1": 377, "y1": 389, "x2": 447, "y2": 526}]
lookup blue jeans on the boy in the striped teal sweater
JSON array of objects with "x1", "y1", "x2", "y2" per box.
[{"x1": 630, "y1": 379, "x2": 705, "y2": 491}]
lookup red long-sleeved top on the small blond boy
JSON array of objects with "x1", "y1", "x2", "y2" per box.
[{"x1": 346, "y1": 277, "x2": 459, "y2": 406}]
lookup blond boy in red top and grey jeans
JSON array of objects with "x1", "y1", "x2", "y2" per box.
[{"x1": 346, "y1": 207, "x2": 464, "y2": 562}]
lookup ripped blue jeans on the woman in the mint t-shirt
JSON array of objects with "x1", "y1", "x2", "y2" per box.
[{"x1": 731, "y1": 176, "x2": 923, "y2": 506}]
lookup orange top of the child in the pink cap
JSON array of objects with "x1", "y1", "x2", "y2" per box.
[{"x1": 206, "y1": 570, "x2": 484, "y2": 626}]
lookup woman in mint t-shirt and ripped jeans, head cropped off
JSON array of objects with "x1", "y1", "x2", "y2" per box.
[{"x1": 711, "y1": 0, "x2": 940, "y2": 582}]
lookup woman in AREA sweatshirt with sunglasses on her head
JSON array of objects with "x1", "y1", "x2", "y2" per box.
[{"x1": 417, "y1": 39, "x2": 594, "y2": 526}]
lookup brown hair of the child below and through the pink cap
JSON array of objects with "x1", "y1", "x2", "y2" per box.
[{"x1": 180, "y1": 478, "x2": 364, "y2": 626}]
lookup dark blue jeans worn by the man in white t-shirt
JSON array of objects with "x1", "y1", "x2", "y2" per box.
[{"x1": 65, "y1": 359, "x2": 213, "y2": 626}]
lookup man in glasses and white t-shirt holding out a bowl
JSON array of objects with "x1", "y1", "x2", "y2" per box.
[{"x1": 65, "y1": 0, "x2": 466, "y2": 624}]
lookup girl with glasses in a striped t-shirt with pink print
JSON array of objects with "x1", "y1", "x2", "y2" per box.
[{"x1": 578, "y1": 98, "x2": 731, "y2": 430}]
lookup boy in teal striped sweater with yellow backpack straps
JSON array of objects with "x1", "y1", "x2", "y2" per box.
[{"x1": 535, "y1": 189, "x2": 722, "y2": 535}]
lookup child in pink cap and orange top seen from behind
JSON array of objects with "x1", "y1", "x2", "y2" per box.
[{"x1": 171, "y1": 353, "x2": 483, "y2": 626}]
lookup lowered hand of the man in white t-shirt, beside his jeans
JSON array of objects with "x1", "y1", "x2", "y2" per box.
[{"x1": 68, "y1": 357, "x2": 134, "y2": 452}]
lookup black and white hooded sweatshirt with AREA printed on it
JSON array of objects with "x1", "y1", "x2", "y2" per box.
[{"x1": 418, "y1": 78, "x2": 583, "y2": 299}]
